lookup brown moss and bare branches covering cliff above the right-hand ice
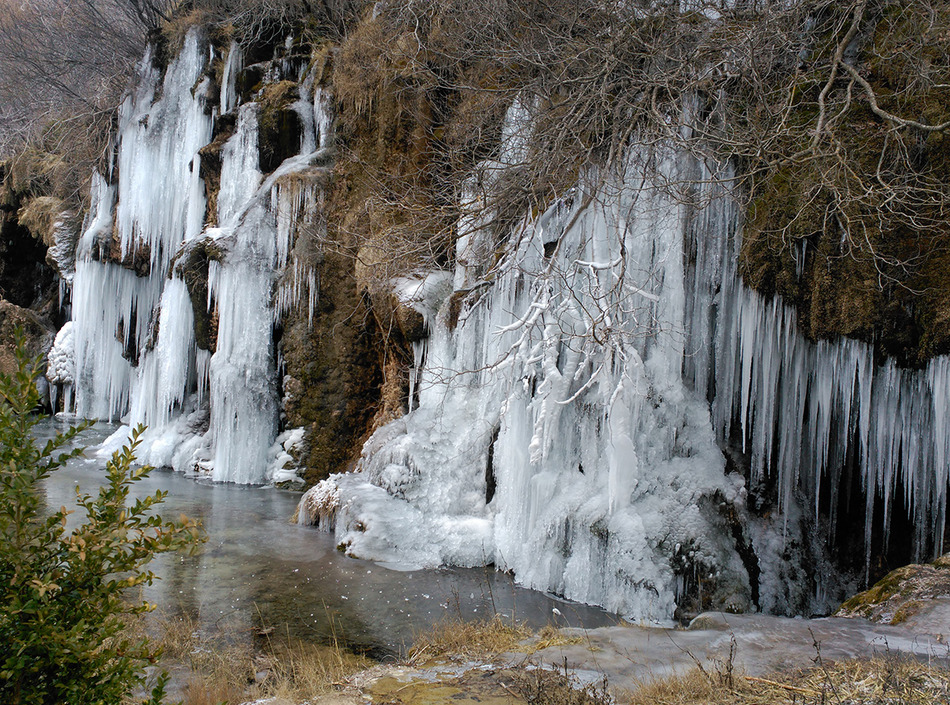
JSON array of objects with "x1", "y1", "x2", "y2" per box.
[{"x1": 322, "y1": 0, "x2": 950, "y2": 374}]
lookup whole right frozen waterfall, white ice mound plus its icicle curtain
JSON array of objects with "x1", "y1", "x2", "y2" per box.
[{"x1": 301, "y1": 96, "x2": 950, "y2": 619}]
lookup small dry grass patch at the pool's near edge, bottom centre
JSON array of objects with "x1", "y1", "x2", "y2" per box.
[{"x1": 409, "y1": 614, "x2": 532, "y2": 664}]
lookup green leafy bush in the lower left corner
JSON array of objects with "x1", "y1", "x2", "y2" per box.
[{"x1": 0, "y1": 340, "x2": 201, "y2": 705}]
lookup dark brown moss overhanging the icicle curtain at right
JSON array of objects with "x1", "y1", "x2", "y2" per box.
[{"x1": 740, "y1": 4, "x2": 950, "y2": 367}]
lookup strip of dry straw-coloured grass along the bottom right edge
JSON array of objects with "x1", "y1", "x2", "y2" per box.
[{"x1": 617, "y1": 657, "x2": 950, "y2": 705}]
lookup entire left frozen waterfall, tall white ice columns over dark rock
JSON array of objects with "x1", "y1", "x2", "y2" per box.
[{"x1": 60, "y1": 31, "x2": 331, "y2": 483}]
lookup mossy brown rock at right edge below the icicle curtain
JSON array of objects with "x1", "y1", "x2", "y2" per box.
[{"x1": 835, "y1": 553, "x2": 950, "y2": 624}]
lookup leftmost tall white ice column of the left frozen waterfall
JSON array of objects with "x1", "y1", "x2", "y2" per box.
[{"x1": 72, "y1": 30, "x2": 211, "y2": 421}]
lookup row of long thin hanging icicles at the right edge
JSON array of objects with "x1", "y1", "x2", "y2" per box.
[{"x1": 713, "y1": 260, "x2": 950, "y2": 564}]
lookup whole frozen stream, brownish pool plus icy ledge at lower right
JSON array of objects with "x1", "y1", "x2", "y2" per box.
[{"x1": 31, "y1": 420, "x2": 950, "y2": 687}]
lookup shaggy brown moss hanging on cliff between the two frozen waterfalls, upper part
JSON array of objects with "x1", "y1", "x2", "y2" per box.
[{"x1": 331, "y1": 8, "x2": 470, "y2": 290}]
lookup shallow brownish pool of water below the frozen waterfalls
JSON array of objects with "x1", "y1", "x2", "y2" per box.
[{"x1": 36, "y1": 419, "x2": 618, "y2": 655}]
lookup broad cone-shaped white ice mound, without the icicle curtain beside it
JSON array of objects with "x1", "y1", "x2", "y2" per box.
[{"x1": 308, "y1": 132, "x2": 749, "y2": 619}]
